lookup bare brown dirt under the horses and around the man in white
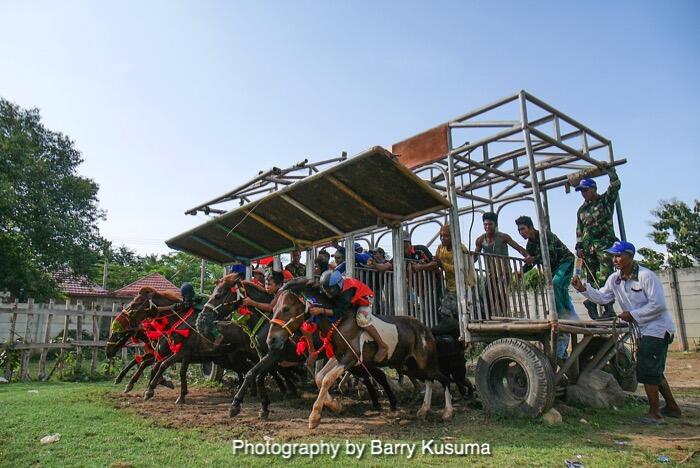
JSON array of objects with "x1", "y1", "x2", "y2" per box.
[{"x1": 110, "y1": 353, "x2": 700, "y2": 456}]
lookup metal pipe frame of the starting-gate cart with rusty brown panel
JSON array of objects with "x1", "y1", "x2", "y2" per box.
[{"x1": 176, "y1": 91, "x2": 626, "y2": 392}]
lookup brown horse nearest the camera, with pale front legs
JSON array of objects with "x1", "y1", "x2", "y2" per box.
[{"x1": 267, "y1": 284, "x2": 454, "y2": 429}]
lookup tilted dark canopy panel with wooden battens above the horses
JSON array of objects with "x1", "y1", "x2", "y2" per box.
[{"x1": 166, "y1": 146, "x2": 449, "y2": 264}]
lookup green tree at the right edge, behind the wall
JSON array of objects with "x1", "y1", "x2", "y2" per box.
[{"x1": 649, "y1": 199, "x2": 700, "y2": 268}]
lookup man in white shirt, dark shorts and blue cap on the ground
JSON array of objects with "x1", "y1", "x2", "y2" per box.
[{"x1": 571, "y1": 241, "x2": 681, "y2": 424}]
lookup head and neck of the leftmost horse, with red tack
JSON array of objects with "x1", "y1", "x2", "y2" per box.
[{"x1": 106, "y1": 287, "x2": 182, "y2": 358}]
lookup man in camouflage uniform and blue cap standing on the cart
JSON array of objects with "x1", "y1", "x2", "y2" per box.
[{"x1": 576, "y1": 168, "x2": 621, "y2": 319}]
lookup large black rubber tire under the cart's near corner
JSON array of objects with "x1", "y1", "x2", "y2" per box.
[{"x1": 476, "y1": 338, "x2": 555, "y2": 418}]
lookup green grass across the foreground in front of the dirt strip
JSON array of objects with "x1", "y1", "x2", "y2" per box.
[{"x1": 0, "y1": 382, "x2": 684, "y2": 466}]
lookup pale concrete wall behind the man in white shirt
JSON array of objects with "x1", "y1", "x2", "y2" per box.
[{"x1": 571, "y1": 267, "x2": 700, "y2": 350}]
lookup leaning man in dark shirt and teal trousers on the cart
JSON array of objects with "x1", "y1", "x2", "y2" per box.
[{"x1": 515, "y1": 216, "x2": 579, "y2": 359}]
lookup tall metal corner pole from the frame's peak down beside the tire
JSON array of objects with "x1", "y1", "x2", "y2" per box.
[{"x1": 520, "y1": 91, "x2": 559, "y2": 355}]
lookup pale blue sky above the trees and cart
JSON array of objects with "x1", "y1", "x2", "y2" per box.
[{"x1": 0, "y1": 1, "x2": 700, "y2": 260}]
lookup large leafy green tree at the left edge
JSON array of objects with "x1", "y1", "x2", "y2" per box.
[{"x1": 0, "y1": 98, "x2": 104, "y2": 299}]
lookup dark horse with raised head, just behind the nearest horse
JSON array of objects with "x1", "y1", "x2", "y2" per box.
[{"x1": 204, "y1": 273, "x2": 396, "y2": 418}]
